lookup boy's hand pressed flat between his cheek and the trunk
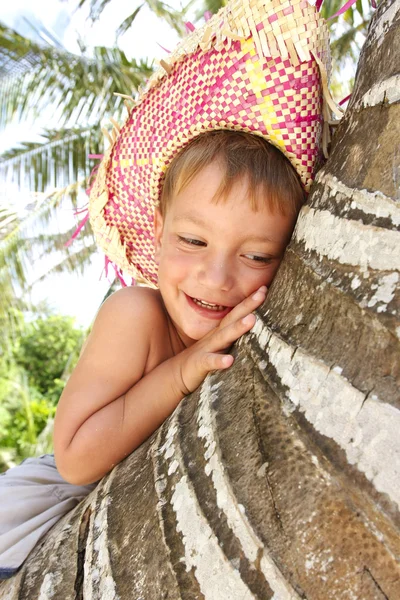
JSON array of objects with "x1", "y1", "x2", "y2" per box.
[{"x1": 178, "y1": 286, "x2": 267, "y2": 396}]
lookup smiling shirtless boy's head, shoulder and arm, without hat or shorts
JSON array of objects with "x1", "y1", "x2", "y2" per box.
[{"x1": 54, "y1": 131, "x2": 304, "y2": 485}]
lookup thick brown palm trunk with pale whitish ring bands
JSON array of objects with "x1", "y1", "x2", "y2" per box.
[{"x1": 0, "y1": 0, "x2": 400, "y2": 600}]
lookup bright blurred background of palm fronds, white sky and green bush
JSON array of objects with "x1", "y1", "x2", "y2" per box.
[{"x1": 0, "y1": 0, "x2": 373, "y2": 471}]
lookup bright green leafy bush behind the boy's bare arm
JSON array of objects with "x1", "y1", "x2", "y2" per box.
[{"x1": 0, "y1": 314, "x2": 84, "y2": 471}]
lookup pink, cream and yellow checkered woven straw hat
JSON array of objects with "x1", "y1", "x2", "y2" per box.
[{"x1": 89, "y1": 0, "x2": 335, "y2": 286}]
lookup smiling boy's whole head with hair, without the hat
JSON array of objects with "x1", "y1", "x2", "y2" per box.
[{"x1": 155, "y1": 131, "x2": 304, "y2": 346}]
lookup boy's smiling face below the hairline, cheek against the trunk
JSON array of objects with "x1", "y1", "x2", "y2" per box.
[{"x1": 155, "y1": 163, "x2": 296, "y2": 346}]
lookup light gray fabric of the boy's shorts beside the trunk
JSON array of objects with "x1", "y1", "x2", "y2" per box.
[{"x1": 0, "y1": 454, "x2": 97, "y2": 579}]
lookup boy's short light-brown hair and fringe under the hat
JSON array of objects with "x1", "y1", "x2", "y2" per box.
[{"x1": 159, "y1": 130, "x2": 306, "y2": 215}]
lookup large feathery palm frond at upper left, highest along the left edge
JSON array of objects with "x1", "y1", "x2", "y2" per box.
[{"x1": 0, "y1": 25, "x2": 152, "y2": 127}]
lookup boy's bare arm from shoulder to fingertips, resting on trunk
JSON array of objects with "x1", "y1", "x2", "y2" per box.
[{"x1": 54, "y1": 290, "x2": 265, "y2": 484}]
